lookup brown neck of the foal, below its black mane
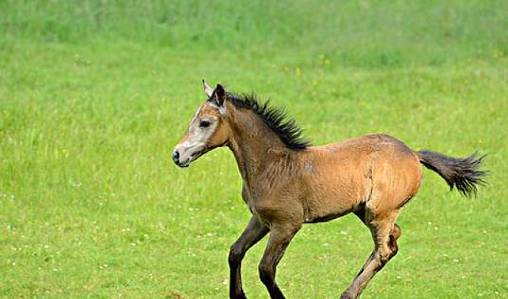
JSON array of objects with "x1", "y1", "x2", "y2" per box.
[{"x1": 228, "y1": 108, "x2": 291, "y2": 186}]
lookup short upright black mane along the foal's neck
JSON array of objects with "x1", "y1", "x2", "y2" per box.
[{"x1": 227, "y1": 93, "x2": 310, "y2": 150}]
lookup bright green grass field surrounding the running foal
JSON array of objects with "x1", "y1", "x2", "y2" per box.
[{"x1": 0, "y1": 0, "x2": 508, "y2": 298}]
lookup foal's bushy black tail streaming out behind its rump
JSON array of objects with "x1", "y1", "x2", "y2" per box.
[{"x1": 417, "y1": 150, "x2": 487, "y2": 197}]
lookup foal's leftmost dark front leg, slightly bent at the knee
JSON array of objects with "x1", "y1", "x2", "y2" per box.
[{"x1": 228, "y1": 216, "x2": 269, "y2": 299}]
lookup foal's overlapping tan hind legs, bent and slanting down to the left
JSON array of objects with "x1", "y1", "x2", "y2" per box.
[{"x1": 341, "y1": 211, "x2": 401, "y2": 298}]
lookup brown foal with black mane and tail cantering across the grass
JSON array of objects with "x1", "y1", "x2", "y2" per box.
[{"x1": 173, "y1": 81, "x2": 485, "y2": 298}]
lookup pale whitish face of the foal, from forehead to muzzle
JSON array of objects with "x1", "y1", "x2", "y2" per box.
[{"x1": 175, "y1": 107, "x2": 218, "y2": 166}]
